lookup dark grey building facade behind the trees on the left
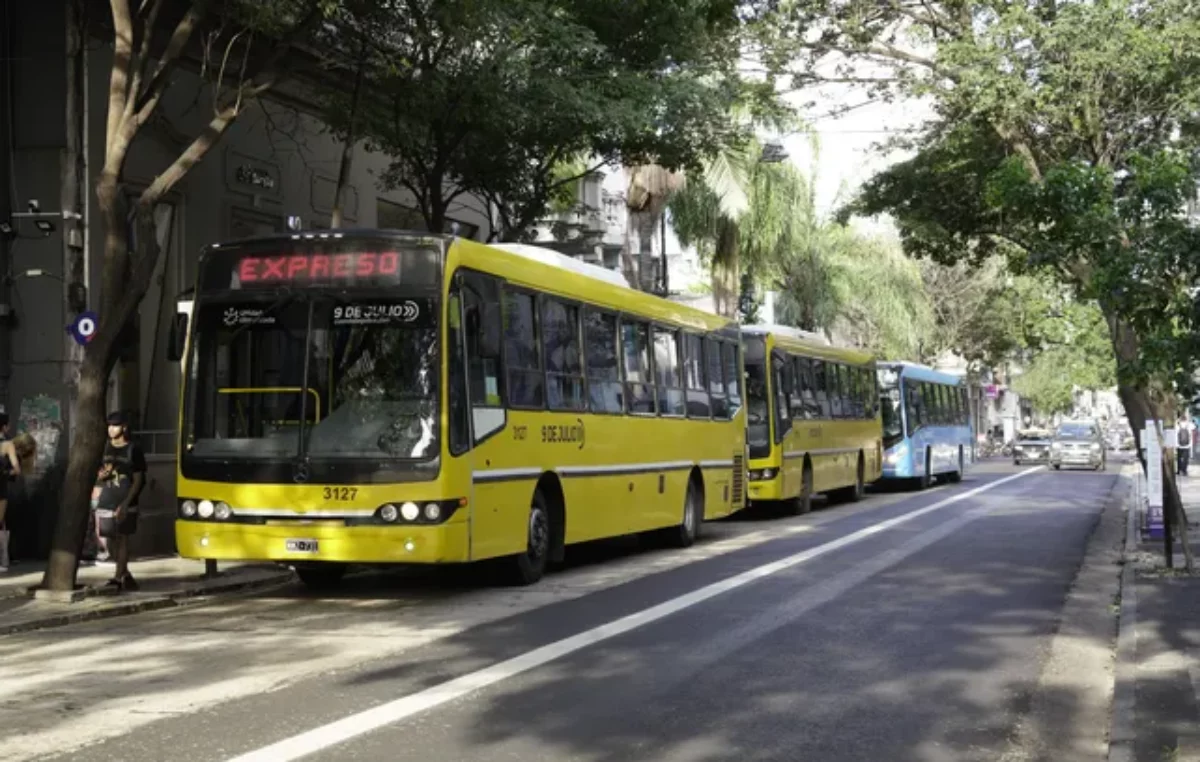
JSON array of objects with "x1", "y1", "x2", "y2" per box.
[{"x1": 0, "y1": 0, "x2": 490, "y2": 554}]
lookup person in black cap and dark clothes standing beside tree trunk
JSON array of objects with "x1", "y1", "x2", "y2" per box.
[{"x1": 95, "y1": 413, "x2": 146, "y2": 593}]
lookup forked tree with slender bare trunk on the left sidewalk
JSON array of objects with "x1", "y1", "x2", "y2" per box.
[{"x1": 42, "y1": 0, "x2": 331, "y2": 590}]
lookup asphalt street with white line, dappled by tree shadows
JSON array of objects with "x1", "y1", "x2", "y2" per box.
[{"x1": 0, "y1": 463, "x2": 1117, "y2": 762}]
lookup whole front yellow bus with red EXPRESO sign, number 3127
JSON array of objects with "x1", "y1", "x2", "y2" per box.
[{"x1": 173, "y1": 230, "x2": 745, "y2": 587}]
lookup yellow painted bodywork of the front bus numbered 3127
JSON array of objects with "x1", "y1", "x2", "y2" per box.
[{"x1": 175, "y1": 239, "x2": 748, "y2": 564}]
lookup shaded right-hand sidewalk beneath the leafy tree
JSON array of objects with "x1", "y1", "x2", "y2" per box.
[{"x1": 1109, "y1": 475, "x2": 1200, "y2": 762}]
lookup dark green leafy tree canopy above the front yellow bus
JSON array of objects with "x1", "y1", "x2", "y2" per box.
[{"x1": 332, "y1": 0, "x2": 738, "y2": 240}]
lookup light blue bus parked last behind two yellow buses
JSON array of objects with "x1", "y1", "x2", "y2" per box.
[{"x1": 876, "y1": 362, "x2": 973, "y2": 490}]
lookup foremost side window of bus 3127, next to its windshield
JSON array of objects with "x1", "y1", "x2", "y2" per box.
[{"x1": 461, "y1": 272, "x2": 505, "y2": 443}]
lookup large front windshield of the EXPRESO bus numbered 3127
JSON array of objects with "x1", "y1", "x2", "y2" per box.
[{"x1": 185, "y1": 290, "x2": 438, "y2": 460}]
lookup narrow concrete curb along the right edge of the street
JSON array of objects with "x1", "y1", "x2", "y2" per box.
[{"x1": 1108, "y1": 465, "x2": 1138, "y2": 762}]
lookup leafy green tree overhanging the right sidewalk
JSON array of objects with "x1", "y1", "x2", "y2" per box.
[{"x1": 782, "y1": 0, "x2": 1200, "y2": 566}]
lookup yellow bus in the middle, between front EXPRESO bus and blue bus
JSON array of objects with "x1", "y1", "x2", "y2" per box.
[{"x1": 742, "y1": 325, "x2": 883, "y2": 515}]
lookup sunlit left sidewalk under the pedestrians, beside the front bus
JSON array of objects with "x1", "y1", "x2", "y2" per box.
[{"x1": 0, "y1": 557, "x2": 293, "y2": 635}]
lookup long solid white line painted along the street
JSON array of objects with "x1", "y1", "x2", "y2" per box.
[{"x1": 228, "y1": 467, "x2": 1042, "y2": 762}]
